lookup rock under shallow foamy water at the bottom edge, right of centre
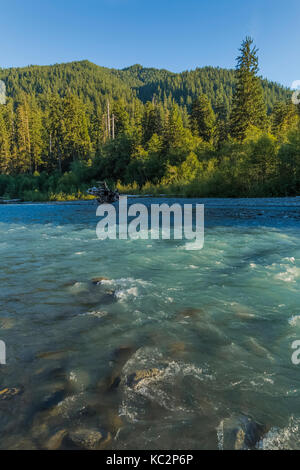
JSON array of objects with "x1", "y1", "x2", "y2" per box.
[{"x1": 218, "y1": 416, "x2": 267, "y2": 450}]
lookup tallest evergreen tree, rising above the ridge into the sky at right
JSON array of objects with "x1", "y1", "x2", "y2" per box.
[{"x1": 230, "y1": 37, "x2": 267, "y2": 140}]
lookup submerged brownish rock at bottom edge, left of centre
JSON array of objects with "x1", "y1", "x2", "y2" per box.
[{"x1": 68, "y1": 428, "x2": 111, "y2": 450}]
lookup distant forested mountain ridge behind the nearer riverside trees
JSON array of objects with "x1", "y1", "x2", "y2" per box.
[{"x1": 0, "y1": 61, "x2": 290, "y2": 112}]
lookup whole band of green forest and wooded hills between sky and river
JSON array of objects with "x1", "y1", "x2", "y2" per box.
[{"x1": 0, "y1": 38, "x2": 300, "y2": 201}]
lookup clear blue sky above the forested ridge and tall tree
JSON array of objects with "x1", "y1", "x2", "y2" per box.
[{"x1": 0, "y1": 0, "x2": 300, "y2": 86}]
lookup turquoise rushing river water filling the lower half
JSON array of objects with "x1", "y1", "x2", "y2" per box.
[{"x1": 0, "y1": 198, "x2": 300, "y2": 449}]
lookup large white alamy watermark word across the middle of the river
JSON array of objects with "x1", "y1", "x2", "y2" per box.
[{"x1": 96, "y1": 196, "x2": 204, "y2": 250}]
